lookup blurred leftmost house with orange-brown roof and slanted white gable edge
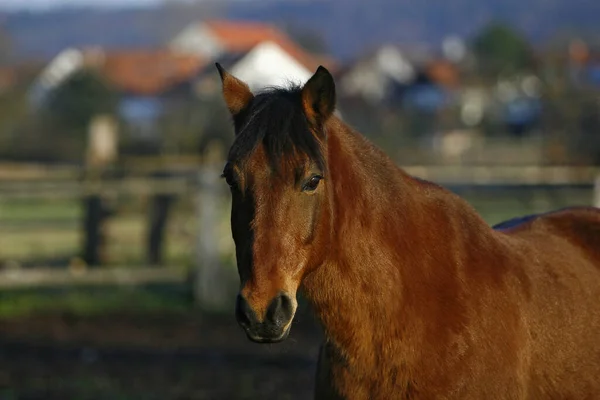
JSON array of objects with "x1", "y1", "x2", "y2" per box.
[{"x1": 30, "y1": 48, "x2": 205, "y2": 135}]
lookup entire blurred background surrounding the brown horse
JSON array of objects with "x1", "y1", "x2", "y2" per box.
[{"x1": 0, "y1": 0, "x2": 600, "y2": 400}]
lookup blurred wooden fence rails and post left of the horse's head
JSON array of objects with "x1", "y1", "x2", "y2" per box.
[{"x1": 0, "y1": 164, "x2": 236, "y2": 309}]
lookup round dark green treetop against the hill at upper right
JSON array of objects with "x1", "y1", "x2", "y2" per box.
[{"x1": 472, "y1": 22, "x2": 534, "y2": 77}]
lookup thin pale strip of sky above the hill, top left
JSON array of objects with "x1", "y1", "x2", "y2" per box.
[{"x1": 0, "y1": 0, "x2": 161, "y2": 11}]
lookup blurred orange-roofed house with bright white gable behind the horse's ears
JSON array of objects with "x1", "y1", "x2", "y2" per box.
[{"x1": 169, "y1": 21, "x2": 335, "y2": 94}]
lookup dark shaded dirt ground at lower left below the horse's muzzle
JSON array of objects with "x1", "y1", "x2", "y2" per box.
[{"x1": 0, "y1": 313, "x2": 321, "y2": 400}]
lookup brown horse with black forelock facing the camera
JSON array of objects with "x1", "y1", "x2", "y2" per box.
[{"x1": 217, "y1": 65, "x2": 600, "y2": 400}]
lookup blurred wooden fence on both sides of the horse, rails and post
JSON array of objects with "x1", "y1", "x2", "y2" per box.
[{"x1": 0, "y1": 163, "x2": 600, "y2": 308}]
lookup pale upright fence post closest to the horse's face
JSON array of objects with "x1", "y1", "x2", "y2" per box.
[{"x1": 194, "y1": 144, "x2": 230, "y2": 311}]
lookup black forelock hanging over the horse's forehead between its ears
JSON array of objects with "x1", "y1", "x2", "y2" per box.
[{"x1": 228, "y1": 85, "x2": 325, "y2": 171}]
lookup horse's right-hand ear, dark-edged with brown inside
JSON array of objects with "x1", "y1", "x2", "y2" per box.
[{"x1": 302, "y1": 66, "x2": 336, "y2": 125}]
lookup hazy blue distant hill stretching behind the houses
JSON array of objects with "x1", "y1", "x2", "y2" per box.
[{"x1": 0, "y1": 0, "x2": 600, "y2": 63}]
